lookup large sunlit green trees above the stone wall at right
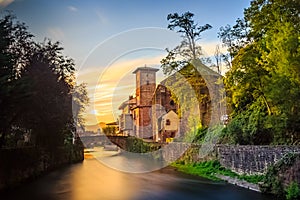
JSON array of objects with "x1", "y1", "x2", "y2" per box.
[{"x1": 219, "y1": 0, "x2": 300, "y2": 145}]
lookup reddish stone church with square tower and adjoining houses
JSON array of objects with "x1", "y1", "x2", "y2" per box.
[{"x1": 119, "y1": 64, "x2": 224, "y2": 142}]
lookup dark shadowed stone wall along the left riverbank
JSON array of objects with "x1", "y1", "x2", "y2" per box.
[{"x1": 0, "y1": 145, "x2": 84, "y2": 190}]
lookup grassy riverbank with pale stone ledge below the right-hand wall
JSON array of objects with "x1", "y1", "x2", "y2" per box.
[{"x1": 171, "y1": 160, "x2": 264, "y2": 192}]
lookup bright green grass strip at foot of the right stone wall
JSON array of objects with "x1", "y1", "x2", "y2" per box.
[{"x1": 171, "y1": 160, "x2": 264, "y2": 184}]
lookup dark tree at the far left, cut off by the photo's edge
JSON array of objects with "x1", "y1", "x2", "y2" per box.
[{"x1": 0, "y1": 14, "x2": 33, "y2": 148}]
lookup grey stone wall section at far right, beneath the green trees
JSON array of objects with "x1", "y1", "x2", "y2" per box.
[{"x1": 216, "y1": 145, "x2": 300, "y2": 174}]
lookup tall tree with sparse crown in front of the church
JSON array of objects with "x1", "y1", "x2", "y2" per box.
[{"x1": 161, "y1": 12, "x2": 212, "y2": 131}]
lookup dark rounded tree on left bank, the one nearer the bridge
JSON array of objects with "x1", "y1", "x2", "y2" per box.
[{"x1": 19, "y1": 46, "x2": 73, "y2": 148}]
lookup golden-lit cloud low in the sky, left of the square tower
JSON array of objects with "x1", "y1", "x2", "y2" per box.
[{"x1": 77, "y1": 55, "x2": 163, "y2": 124}]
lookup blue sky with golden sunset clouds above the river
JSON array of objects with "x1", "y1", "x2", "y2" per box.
[{"x1": 0, "y1": 0, "x2": 250, "y2": 125}]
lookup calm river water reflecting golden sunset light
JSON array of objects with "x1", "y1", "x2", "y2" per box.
[{"x1": 0, "y1": 148, "x2": 271, "y2": 200}]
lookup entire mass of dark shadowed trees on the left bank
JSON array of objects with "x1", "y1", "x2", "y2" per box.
[{"x1": 0, "y1": 14, "x2": 88, "y2": 149}]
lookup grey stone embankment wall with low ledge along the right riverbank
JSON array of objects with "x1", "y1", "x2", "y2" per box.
[{"x1": 157, "y1": 142, "x2": 300, "y2": 191}]
